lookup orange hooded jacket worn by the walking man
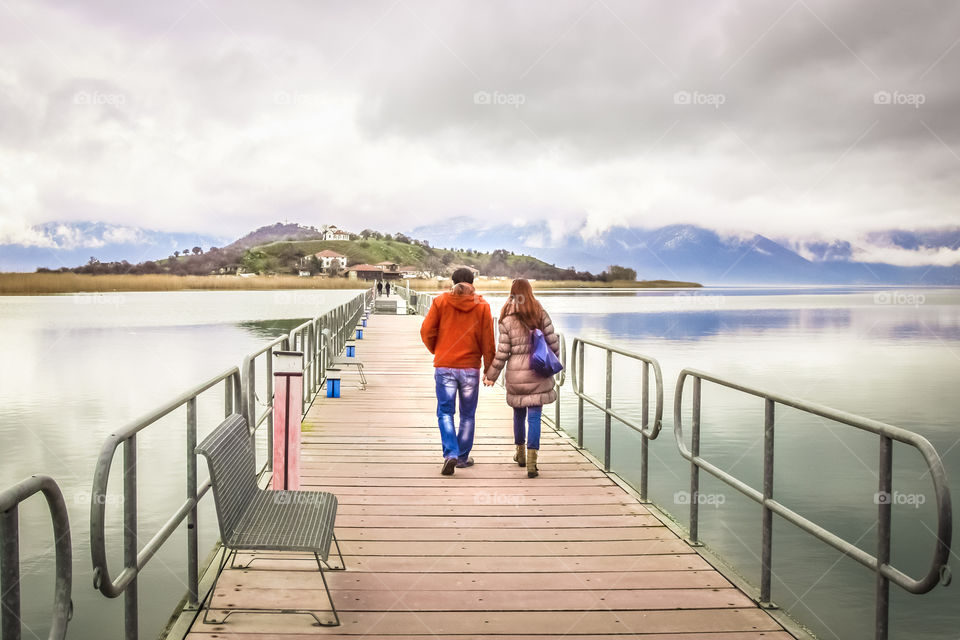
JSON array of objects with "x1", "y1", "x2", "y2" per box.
[{"x1": 420, "y1": 282, "x2": 495, "y2": 370}]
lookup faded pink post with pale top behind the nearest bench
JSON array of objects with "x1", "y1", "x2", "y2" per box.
[{"x1": 271, "y1": 351, "x2": 303, "y2": 490}]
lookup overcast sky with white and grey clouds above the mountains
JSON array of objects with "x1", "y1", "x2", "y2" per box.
[{"x1": 0, "y1": 0, "x2": 960, "y2": 249}]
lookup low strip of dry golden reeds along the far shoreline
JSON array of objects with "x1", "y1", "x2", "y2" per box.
[{"x1": 0, "y1": 273, "x2": 701, "y2": 296}]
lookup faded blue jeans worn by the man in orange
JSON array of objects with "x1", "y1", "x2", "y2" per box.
[{"x1": 433, "y1": 367, "x2": 480, "y2": 460}]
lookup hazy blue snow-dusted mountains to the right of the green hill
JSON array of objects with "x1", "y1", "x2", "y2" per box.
[{"x1": 408, "y1": 218, "x2": 960, "y2": 285}]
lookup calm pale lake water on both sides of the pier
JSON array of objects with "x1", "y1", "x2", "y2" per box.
[{"x1": 0, "y1": 288, "x2": 960, "y2": 640}]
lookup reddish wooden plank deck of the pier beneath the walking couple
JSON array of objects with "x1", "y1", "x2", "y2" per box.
[{"x1": 187, "y1": 315, "x2": 792, "y2": 640}]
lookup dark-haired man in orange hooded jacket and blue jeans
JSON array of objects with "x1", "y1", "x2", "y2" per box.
[{"x1": 420, "y1": 268, "x2": 494, "y2": 476}]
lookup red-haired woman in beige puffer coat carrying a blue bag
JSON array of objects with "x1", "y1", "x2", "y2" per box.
[{"x1": 483, "y1": 278, "x2": 560, "y2": 478}]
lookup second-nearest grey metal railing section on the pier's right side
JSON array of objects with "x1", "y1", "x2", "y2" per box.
[{"x1": 570, "y1": 338, "x2": 663, "y2": 500}]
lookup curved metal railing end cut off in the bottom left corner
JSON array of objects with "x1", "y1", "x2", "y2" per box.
[{"x1": 0, "y1": 475, "x2": 73, "y2": 640}]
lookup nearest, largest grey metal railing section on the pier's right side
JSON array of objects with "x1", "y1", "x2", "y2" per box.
[{"x1": 673, "y1": 369, "x2": 953, "y2": 640}]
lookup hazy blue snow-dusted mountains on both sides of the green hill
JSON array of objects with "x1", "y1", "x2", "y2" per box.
[{"x1": 0, "y1": 217, "x2": 960, "y2": 285}]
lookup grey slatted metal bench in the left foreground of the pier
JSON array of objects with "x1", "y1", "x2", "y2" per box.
[{"x1": 196, "y1": 414, "x2": 346, "y2": 627}]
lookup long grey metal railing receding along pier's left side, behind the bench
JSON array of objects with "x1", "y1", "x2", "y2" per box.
[{"x1": 90, "y1": 291, "x2": 371, "y2": 640}]
